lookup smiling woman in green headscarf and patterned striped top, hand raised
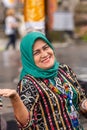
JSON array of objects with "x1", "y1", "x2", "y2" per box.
[{"x1": 0, "y1": 32, "x2": 87, "y2": 130}]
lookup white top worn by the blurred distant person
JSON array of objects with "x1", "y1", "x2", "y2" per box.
[{"x1": 5, "y1": 16, "x2": 17, "y2": 35}]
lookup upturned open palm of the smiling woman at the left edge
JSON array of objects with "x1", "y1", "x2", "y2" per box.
[{"x1": 0, "y1": 89, "x2": 17, "y2": 98}]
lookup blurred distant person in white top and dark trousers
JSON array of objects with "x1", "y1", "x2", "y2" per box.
[{"x1": 5, "y1": 9, "x2": 18, "y2": 50}]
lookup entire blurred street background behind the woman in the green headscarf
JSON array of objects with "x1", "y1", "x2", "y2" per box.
[{"x1": 0, "y1": 0, "x2": 87, "y2": 130}]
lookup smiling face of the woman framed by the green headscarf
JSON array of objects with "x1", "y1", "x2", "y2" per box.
[{"x1": 33, "y1": 39, "x2": 55, "y2": 69}]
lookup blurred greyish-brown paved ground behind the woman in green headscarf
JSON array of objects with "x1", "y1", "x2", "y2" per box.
[{"x1": 0, "y1": 39, "x2": 87, "y2": 130}]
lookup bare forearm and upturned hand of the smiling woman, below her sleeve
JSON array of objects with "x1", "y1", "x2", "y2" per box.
[{"x1": 0, "y1": 89, "x2": 29, "y2": 125}]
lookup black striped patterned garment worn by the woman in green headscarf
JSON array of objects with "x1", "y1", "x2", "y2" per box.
[{"x1": 18, "y1": 65, "x2": 85, "y2": 130}]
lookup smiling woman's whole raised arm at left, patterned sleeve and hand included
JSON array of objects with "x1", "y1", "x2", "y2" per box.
[{"x1": 0, "y1": 78, "x2": 39, "y2": 129}]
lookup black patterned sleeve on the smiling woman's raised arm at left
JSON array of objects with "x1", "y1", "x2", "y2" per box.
[{"x1": 16, "y1": 78, "x2": 39, "y2": 130}]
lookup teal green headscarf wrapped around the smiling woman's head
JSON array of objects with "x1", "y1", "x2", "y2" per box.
[{"x1": 20, "y1": 32, "x2": 59, "y2": 79}]
